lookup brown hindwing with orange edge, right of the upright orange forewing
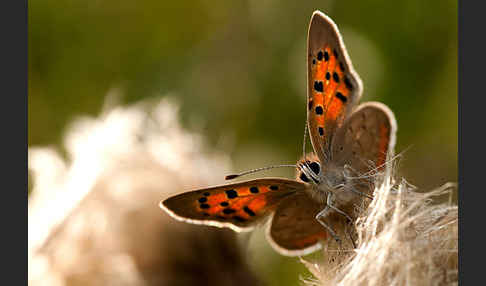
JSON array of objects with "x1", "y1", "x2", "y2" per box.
[{"x1": 332, "y1": 102, "x2": 397, "y2": 180}]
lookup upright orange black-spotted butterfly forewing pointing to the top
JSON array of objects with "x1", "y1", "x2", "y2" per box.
[{"x1": 307, "y1": 11, "x2": 362, "y2": 162}]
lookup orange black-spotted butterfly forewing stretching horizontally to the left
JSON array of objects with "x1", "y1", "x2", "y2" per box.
[{"x1": 160, "y1": 178, "x2": 305, "y2": 232}]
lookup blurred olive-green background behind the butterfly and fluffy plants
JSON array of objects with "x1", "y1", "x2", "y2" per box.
[{"x1": 28, "y1": 0, "x2": 458, "y2": 285}]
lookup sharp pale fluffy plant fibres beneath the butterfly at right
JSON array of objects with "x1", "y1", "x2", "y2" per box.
[{"x1": 301, "y1": 170, "x2": 458, "y2": 285}]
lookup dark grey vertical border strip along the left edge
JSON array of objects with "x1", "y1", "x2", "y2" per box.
[{"x1": 0, "y1": 1, "x2": 28, "y2": 285}]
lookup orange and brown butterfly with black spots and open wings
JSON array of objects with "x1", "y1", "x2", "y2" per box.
[{"x1": 160, "y1": 11, "x2": 397, "y2": 256}]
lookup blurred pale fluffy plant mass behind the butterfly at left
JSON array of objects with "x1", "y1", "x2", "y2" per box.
[{"x1": 28, "y1": 96, "x2": 260, "y2": 286}]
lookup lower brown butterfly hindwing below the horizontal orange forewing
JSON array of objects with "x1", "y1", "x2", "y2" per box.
[{"x1": 267, "y1": 192, "x2": 328, "y2": 256}]
